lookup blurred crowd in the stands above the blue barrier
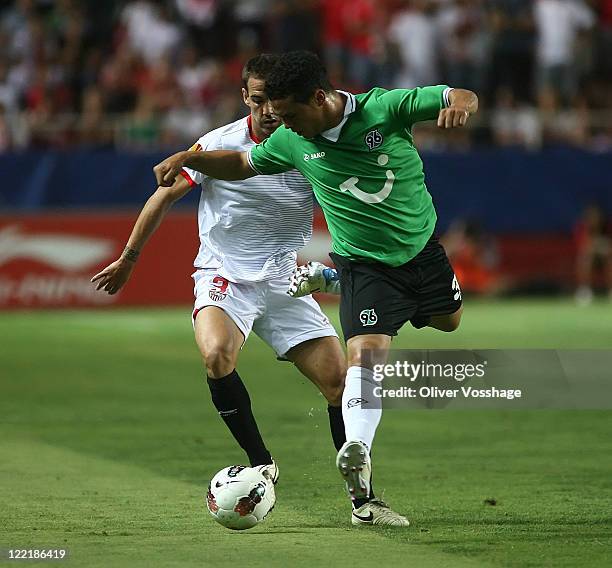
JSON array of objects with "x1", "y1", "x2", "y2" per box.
[{"x1": 0, "y1": 0, "x2": 612, "y2": 151}]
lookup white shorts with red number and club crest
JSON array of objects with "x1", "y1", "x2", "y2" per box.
[{"x1": 192, "y1": 269, "x2": 338, "y2": 357}]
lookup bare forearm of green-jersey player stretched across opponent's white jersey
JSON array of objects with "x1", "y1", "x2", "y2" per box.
[{"x1": 153, "y1": 150, "x2": 257, "y2": 187}]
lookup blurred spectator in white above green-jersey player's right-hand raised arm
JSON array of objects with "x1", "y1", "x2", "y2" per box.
[{"x1": 389, "y1": 0, "x2": 440, "y2": 89}]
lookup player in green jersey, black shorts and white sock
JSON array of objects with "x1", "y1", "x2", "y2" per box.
[{"x1": 154, "y1": 52, "x2": 478, "y2": 525}]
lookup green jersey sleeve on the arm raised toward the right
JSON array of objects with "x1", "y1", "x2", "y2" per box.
[{"x1": 379, "y1": 85, "x2": 452, "y2": 127}]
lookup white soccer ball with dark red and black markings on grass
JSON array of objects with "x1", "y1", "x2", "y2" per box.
[{"x1": 206, "y1": 465, "x2": 276, "y2": 531}]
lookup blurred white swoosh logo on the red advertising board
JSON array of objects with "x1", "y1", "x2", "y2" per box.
[{"x1": 0, "y1": 225, "x2": 114, "y2": 271}]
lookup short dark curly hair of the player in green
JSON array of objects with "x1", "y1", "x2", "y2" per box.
[{"x1": 266, "y1": 51, "x2": 334, "y2": 103}]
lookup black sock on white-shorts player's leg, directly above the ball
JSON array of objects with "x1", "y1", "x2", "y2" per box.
[{"x1": 207, "y1": 369, "x2": 272, "y2": 466}]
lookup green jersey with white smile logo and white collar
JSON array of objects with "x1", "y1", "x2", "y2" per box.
[{"x1": 249, "y1": 85, "x2": 450, "y2": 266}]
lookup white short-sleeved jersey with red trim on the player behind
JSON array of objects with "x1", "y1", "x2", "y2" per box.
[{"x1": 183, "y1": 116, "x2": 313, "y2": 282}]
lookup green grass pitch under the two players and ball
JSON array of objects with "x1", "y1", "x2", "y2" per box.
[{"x1": 0, "y1": 300, "x2": 612, "y2": 568}]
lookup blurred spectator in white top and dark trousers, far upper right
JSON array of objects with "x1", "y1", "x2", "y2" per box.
[{"x1": 535, "y1": 0, "x2": 595, "y2": 104}]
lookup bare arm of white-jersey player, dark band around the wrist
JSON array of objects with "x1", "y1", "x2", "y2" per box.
[{"x1": 91, "y1": 176, "x2": 191, "y2": 295}]
